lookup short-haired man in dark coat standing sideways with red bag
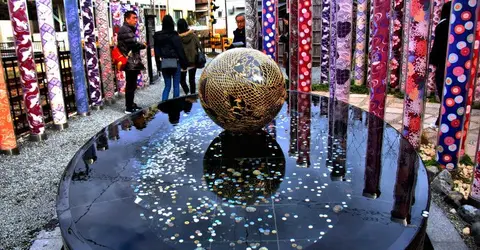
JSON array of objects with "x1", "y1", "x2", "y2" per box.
[{"x1": 117, "y1": 11, "x2": 147, "y2": 114}]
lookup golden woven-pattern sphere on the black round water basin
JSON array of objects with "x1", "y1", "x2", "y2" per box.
[{"x1": 199, "y1": 48, "x2": 286, "y2": 132}]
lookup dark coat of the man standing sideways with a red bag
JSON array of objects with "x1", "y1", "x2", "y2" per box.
[{"x1": 117, "y1": 23, "x2": 146, "y2": 71}]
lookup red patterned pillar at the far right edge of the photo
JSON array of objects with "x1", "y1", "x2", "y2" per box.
[{"x1": 460, "y1": 4, "x2": 480, "y2": 157}]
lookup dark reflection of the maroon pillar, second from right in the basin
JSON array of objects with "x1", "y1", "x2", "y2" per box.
[{"x1": 363, "y1": 114, "x2": 384, "y2": 199}]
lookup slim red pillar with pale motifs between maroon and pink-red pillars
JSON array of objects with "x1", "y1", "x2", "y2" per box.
[{"x1": 390, "y1": 0, "x2": 408, "y2": 89}]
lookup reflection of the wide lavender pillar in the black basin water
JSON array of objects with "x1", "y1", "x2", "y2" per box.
[{"x1": 328, "y1": 101, "x2": 348, "y2": 181}]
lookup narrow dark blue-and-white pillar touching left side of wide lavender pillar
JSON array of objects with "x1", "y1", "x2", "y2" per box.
[{"x1": 320, "y1": 0, "x2": 332, "y2": 84}]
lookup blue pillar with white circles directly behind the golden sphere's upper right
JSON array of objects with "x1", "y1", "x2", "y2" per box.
[{"x1": 262, "y1": 0, "x2": 278, "y2": 61}]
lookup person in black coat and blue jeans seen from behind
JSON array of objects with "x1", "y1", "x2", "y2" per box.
[{"x1": 153, "y1": 15, "x2": 188, "y2": 101}]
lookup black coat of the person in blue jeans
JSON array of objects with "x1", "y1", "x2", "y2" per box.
[{"x1": 153, "y1": 30, "x2": 188, "y2": 70}]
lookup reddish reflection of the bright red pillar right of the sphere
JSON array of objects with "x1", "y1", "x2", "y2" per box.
[{"x1": 297, "y1": 93, "x2": 312, "y2": 167}]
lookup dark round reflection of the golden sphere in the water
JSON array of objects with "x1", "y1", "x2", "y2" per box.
[{"x1": 204, "y1": 131, "x2": 285, "y2": 205}]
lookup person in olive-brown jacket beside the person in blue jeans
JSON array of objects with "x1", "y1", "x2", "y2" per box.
[{"x1": 177, "y1": 18, "x2": 203, "y2": 94}]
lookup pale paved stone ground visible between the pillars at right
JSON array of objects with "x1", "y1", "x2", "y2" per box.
[{"x1": 314, "y1": 91, "x2": 480, "y2": 159}]
